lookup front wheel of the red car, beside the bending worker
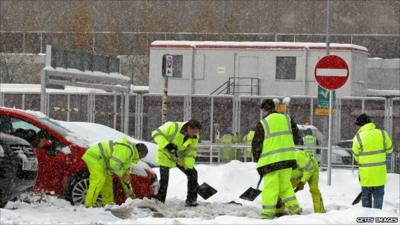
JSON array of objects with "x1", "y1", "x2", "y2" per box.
[{"x1": 65, "y1": 171, "x2": 101, "y2": 206}]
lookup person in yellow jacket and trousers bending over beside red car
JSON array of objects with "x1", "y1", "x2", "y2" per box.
[{"x1": 82, "y1": 136, "x2": 148, "y2": 207}]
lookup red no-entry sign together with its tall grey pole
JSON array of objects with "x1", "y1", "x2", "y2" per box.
[{"x1": 314, "y1": 55, "x2": 349, "y2": 186}]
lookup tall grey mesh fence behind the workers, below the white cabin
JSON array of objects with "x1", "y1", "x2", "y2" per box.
[{"x1": 0, "y1": 92, "x2": 400, "y2": 172}]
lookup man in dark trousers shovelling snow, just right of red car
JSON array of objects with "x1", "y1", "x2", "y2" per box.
[{"x1": 152, "y1": 120, "x2": 201, "y2": 207}]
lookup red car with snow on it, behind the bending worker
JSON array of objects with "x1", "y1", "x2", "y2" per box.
[{"x1": 0, "y1": 107, "x2": 158, "y2": 204}]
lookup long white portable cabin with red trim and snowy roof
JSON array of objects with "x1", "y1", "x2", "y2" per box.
[{"x1": 149, "y1": 41, "x2": 368, "y2": 96}]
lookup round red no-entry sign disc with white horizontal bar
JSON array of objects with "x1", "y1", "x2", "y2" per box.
[{"x1": 314, "y1": 55, "x2": 349, "y2": 90}]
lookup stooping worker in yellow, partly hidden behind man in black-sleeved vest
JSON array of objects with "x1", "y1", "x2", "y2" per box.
[{"x1": 277, "y1": 150, "x2": 326, "y2": 214}]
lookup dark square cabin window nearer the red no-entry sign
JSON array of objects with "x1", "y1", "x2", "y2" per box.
[{"x1": 275, "y1": 56, "x2": 296, "y2": 80}]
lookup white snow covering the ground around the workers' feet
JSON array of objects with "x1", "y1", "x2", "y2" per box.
[{"x1": 0, "y1": 161, "x2": 400, "y2": 224}]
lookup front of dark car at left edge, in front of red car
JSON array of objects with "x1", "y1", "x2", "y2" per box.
[{"x1": 0, "y1": 132, "x2": 37, "y2": 208}]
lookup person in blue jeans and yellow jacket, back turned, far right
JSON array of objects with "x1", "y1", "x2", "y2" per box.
[{"x1": 353, "y1": 113, "x2": 393, "y2": 209}]
